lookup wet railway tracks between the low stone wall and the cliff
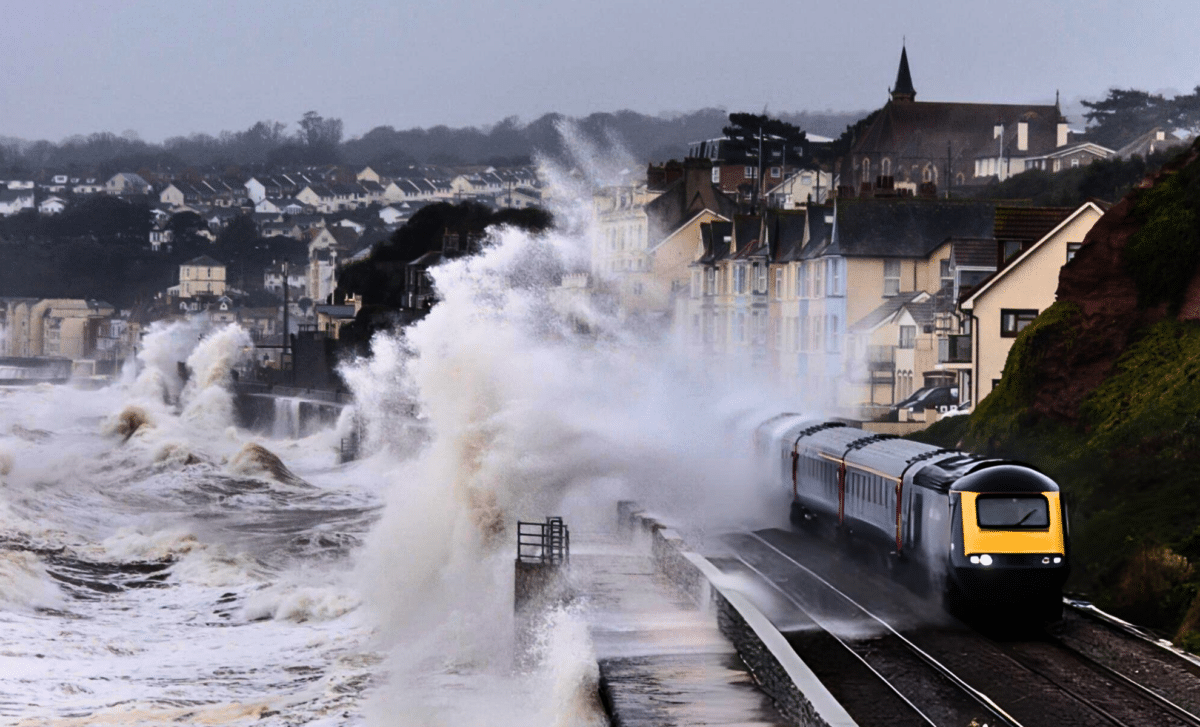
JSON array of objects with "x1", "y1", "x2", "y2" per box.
[{"x1": 714, "y1": 531, "x2": 1200, "y2": 727}]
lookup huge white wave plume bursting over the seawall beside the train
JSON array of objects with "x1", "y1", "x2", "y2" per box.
[{"x1": 347, "y1": 229, "x2": 777, "y2": 725}]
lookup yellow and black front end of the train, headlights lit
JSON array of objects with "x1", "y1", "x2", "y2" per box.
[{"x1": 949, "y1": 462, "x2": 1069, "y2": 619}]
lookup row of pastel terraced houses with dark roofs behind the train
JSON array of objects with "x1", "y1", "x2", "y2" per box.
[{"x1": 676, "y1": 199, "x2": 994, "y2": 416}]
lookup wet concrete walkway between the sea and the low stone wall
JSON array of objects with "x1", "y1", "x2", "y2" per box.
[{"x1": 571, "y1": 531, "x2": 787, "y2": 727}]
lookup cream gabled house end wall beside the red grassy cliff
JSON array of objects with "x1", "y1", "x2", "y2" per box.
[{"x1": 958, "y1": 202, "x2": 1104, "y2": 403}]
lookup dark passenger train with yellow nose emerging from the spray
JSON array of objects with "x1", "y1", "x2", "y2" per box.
[{"x1": 754, "y1": 414, "x2": 1070, "y2": 621}]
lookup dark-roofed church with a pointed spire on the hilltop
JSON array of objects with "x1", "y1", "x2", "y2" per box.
[{"x1": 840, "y1": 48, "x2": 1114, "y2": 196}]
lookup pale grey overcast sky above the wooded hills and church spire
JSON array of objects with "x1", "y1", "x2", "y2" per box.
[{"x1": 0, "y1": 0, "x2": 1200, "y2": 142}]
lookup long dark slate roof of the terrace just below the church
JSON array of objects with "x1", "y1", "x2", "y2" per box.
[{"x1": 820, "y1": 199, "x2": 995, "y2": 258}]
